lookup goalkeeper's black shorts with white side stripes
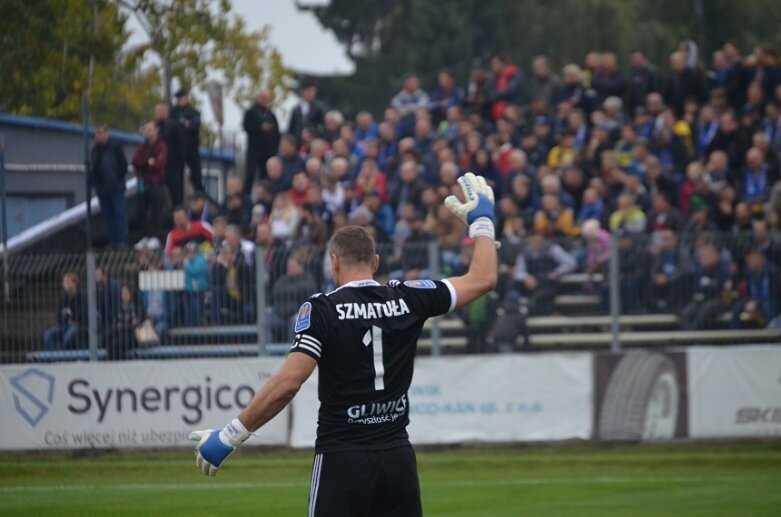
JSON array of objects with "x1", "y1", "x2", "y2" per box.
[{"x1": 308, "y1": 445, "x2": 423, "y2": 517}]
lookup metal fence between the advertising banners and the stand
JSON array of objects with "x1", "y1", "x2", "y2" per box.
[{"x1": 0, "y1": 227, "x2": 781, "y2": 363}]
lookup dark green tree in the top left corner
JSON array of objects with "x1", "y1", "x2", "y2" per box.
[{"x1": 0, "y1": 0, "x2": 159, "y2": 129}]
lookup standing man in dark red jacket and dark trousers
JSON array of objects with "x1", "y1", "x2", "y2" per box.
[{"x1": 133, "y1": 122, "x2": 168, "y2": 249}]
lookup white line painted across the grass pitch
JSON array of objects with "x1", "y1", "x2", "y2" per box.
[{"x1": 0, "y1": 476, "x2": 779, "y2": 494}]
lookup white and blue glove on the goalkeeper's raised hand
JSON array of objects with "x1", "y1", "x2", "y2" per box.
[{"x1": 445, "y1": 172, "x2": 498, "y2": 247}]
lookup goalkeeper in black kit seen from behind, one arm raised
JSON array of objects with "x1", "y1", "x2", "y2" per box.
[{"x1": 190, "y1": 173, "x2": 497, "y2": 517}]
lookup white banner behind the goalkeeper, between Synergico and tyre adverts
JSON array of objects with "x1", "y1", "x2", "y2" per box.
[{"x1": 290, "y1": 353, "x2": 594, "y2": 447}]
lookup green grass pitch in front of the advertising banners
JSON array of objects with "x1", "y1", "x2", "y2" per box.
[{"x1": 0, "y1": 440, "x2": 781, "y2": 517}]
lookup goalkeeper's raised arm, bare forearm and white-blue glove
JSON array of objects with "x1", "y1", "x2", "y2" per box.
[{"x1": 445, "y1": 172, "x2": 498, "y2": 308}]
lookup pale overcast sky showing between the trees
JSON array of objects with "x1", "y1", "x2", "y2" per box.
[{"x1": 125, "y1": 0, "x2": 353, "y2": 139}]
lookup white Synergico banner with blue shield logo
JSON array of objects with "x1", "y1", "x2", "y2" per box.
[{"x1": 0, "y1": 359, "x2": 288, "y2": 450}]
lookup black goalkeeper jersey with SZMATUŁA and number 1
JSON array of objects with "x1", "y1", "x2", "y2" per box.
[{"x1": 291, "y1": 280, "x2": 456, "y2": 452}]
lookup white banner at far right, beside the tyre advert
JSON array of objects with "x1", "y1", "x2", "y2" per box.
[{"x1": 688, "y1": 345, "x2": 781, "y2": 438}]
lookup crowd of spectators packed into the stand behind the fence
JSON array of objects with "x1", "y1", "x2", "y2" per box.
[{"x1": 74, "y1": 41, "x2": 781, "y2": 354}]
